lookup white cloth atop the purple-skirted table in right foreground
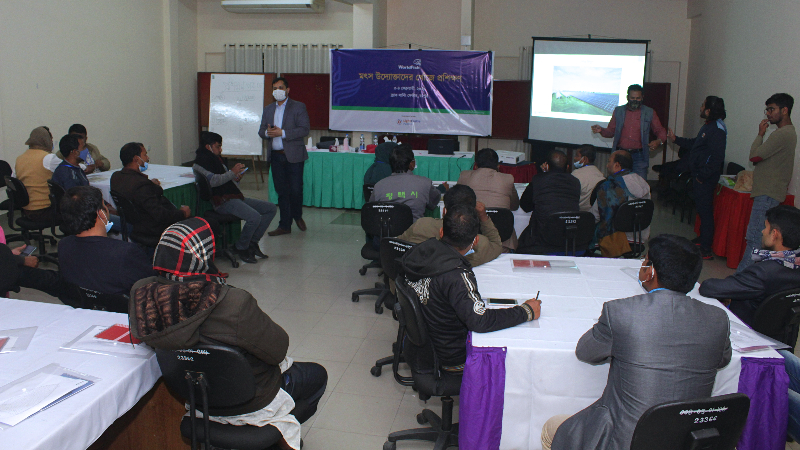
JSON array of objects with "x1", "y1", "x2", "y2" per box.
[{"x1": 472, "y1": 255, "x2": 780, "y2": 450}]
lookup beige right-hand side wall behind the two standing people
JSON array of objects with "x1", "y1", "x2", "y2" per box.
[{"x1": 686, "y1": 0, "x2": 800, "y2": 200}]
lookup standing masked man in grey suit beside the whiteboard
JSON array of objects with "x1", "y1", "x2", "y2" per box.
[{"x1": 258, "y1": 77, "x2": 310, "y2": 236}]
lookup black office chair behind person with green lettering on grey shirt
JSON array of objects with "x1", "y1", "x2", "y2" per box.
[{"x1": 352, "y1": 202, "x2": 414, "y2": 308}]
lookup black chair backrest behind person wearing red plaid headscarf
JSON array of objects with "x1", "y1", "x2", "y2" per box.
[{"x1": 156, "y1": 344, "x2": 256, "y2": 415}]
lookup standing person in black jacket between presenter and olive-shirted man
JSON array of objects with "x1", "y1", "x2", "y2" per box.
[{"x1": 667, "y1": 95, "x2": 728, "y2": 259}]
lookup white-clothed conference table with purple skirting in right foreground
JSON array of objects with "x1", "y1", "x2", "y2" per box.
[{"x1": 459, "y1": 255, "x2": 788, "y2": 450}]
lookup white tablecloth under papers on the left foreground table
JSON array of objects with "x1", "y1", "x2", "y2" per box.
[{"x1": 0, "y1": 298, "x2": 161, "y2": 450}]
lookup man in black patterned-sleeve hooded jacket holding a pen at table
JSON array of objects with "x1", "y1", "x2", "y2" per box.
[{"x1": 401, "y1": 205, "x2": 541, "y2": 373}]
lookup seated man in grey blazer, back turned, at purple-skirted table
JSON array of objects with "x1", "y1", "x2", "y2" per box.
[{"x1": 542, "y1": 235, "x2": 731, "y2": 450}]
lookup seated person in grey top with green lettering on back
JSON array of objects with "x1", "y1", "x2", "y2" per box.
[{"x1": 369, "y1": 144, "x2": 446, "y2": 221}]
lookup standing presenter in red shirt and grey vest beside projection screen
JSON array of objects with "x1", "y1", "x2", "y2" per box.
[{"x1": 592, "y1": 84, "x2": 667, "y2": 180}]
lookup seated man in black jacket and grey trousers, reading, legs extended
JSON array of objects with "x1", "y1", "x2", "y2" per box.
[{"x1": 192, "y1": 131, "x2": 278, "y2": 264}]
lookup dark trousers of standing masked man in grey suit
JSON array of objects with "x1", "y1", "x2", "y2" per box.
[{"x1": 270, "y1": 152, "x2": 305, "y2": 230}]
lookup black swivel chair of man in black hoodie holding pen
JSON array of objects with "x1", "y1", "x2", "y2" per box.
[{"x1": 383, "y1": 276, "x2": 462, "y2": 450}]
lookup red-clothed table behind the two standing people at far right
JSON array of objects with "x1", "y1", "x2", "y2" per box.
[{"x1": 694, "y1": 184, "x2": 794, "y2": 269}]
